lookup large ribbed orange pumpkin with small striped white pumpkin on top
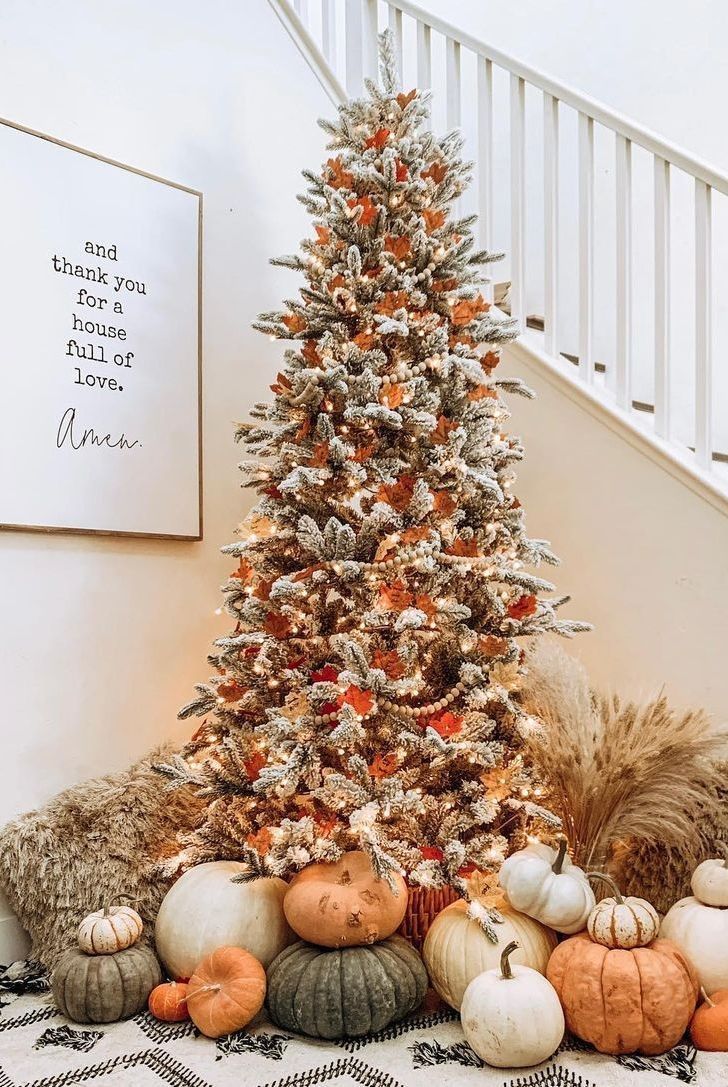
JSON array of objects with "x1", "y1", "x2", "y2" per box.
[{"x1": 547, "y1": 933, "x2": 698, "y2": 1055}]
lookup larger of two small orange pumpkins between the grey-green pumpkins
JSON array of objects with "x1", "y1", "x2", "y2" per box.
[{"x1": 187, "y1": 948, "x2": 265, "y2": 1038}]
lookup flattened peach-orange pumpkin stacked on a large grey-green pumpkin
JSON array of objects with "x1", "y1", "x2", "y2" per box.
[{"x1": 284, "y1": 850, "x2": 407, "y2": 948}]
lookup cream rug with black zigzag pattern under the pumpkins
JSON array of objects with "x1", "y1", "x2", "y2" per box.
[{"x1": 0, "y1": 989, "x2": 728, "y2": 1087}]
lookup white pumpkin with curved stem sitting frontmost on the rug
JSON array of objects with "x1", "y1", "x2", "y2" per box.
[{"x1": 460, "y1": 940, "x2": 564, "y2": 1069}]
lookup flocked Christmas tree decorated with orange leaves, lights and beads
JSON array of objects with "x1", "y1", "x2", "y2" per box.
[{"x1": 165, "y1": 36, "x2": 582, "y2": 925}]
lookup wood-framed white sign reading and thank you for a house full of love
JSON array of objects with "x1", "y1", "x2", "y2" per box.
[{"x1": 0, "y1": 121, "x2": 202, "y2": 539}]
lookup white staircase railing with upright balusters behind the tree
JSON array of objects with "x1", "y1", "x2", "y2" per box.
[{"x1": 277, "y1": 0, "x2": 728, "y2": 503}]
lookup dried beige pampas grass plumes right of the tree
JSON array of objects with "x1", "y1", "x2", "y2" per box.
[{"x1": 523, "y1": 639, "x2": 728, "y2": 869}]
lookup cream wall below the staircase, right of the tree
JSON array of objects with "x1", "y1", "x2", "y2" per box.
[{"x1": 503, "y1": 350, "x2": 728, "y2": 720}]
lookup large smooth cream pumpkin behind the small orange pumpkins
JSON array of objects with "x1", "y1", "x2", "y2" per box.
[{"x1": 154, "y1": 861, "x2": 298, "y2": 979}]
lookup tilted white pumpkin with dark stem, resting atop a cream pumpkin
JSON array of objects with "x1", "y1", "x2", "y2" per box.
[{"x1": 498, "y1": 838, "x2": 595, "y2": 934}]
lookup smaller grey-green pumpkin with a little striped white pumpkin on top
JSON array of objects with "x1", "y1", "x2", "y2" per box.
[{"x1": 51, "y1": 945, "x2": 162, "y2": 1023}]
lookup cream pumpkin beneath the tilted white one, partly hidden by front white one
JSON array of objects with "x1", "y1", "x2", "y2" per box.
[{"x1": 423, "y1": 896, "x2": 556, "y2": 1009}]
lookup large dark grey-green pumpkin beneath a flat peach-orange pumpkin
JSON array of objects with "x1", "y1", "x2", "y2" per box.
[{"x1": 267, "y1": 936, "x2": 427, "y2": 1038}]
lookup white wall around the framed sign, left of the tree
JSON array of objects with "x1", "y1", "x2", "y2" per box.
[{"x1": 0, "y1": 0, "x2": 330, "y2": 962}]
